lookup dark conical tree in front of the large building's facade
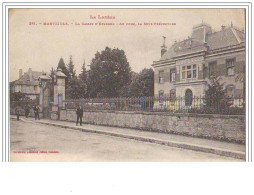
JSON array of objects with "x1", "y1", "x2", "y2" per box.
[{"x1": 205, "y1": 76, "x2": 232, "y2": 112}]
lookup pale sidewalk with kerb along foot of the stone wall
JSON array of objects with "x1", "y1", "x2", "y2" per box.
[{"x1": 11, "y1": 116, "x2": 245, "y2": 160}]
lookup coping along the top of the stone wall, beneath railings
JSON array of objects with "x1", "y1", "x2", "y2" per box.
[{"x1": 62, "y1": 109, "x2": 246, "y2": 119}]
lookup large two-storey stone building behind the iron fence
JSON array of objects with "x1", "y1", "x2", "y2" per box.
[{"x1": 152, "y1": 23, "x2": 245, "y2": 106}]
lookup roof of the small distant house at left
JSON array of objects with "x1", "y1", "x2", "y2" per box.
[{"x1": 14, "y1": 70, "x2": 42, "y2": 85}]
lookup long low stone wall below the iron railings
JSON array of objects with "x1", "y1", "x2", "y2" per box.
[{"x1": 58, "y1": 109, "x2": 245, "y2": 143}]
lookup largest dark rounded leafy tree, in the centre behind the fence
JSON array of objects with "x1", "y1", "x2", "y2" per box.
[{"x1": 88, "y1": 47, "x2": 131, "y2": 97}]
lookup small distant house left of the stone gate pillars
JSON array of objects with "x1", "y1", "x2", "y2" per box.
[{"x1": 10, "y1": 68, "x2": 43, "y2": 100}]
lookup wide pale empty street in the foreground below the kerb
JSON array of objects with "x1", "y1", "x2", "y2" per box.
[{"x1": 10, "y1": 120, "x2": 242, "y2": 162}]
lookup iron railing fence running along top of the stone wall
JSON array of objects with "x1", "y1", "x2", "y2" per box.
[{"x1": 64, "y1": 96, "x2": 245, "y2": 114}]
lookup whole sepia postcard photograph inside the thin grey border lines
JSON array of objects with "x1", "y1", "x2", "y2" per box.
[{"x1": 8, "y1": 7, "x2": 248, "y2": 162}]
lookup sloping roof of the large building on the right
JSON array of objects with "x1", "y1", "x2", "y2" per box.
[{"x1": 160, "y1": 27, "x2": 245, "y2": 60}]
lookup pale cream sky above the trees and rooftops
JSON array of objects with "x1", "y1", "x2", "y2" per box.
[{"x1": 9, "y1": 9, "x2": 245, "y2": 81}]
